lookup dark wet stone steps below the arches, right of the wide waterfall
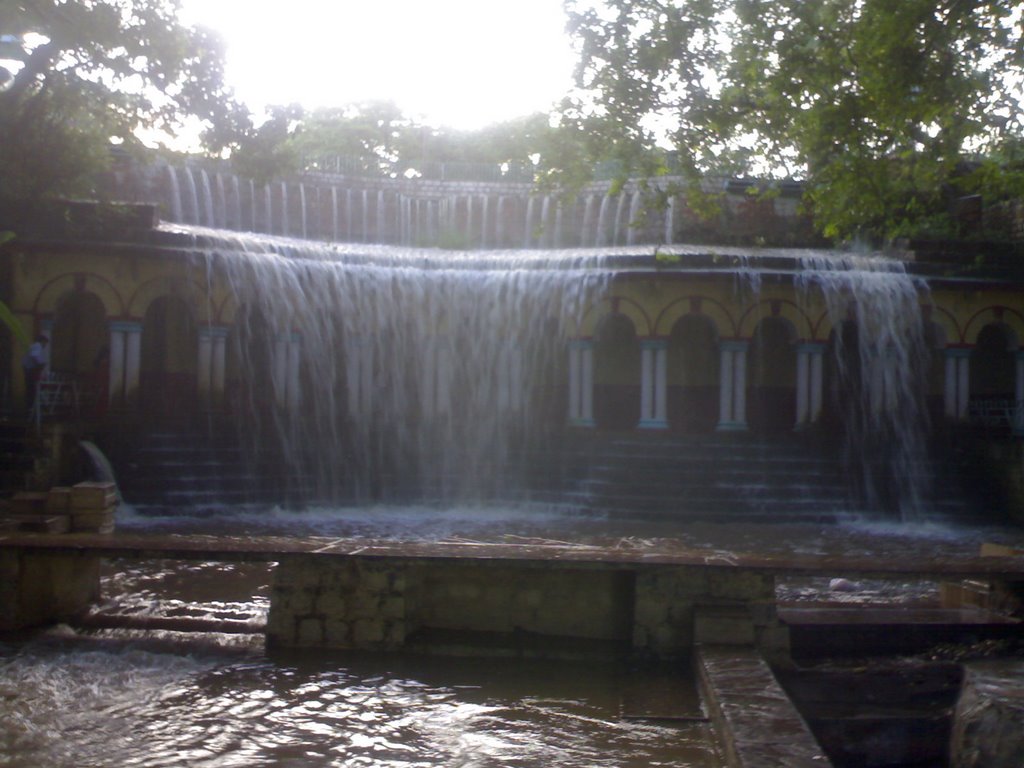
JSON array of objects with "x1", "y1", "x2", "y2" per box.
[{"x1": 540, "y1": 433, "x2": 967, "y2": 522}]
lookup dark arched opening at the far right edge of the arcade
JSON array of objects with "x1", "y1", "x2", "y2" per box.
[{"x1": 969, "y1": 323, "x2": 1018, "y2": 427}]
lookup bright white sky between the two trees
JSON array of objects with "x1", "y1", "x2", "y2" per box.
[{"x1": 182, "y1": 0, "x2": 573, "y2": 129}]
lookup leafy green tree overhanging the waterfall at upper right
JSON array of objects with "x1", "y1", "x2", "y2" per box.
[{"x1": 562, "y1": 0, "x2": 1024, "y2": 239}]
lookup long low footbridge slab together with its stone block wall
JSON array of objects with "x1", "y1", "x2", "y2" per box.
[{"x1": 0, "y1": 534, "x2": 1024, "y2": 657}]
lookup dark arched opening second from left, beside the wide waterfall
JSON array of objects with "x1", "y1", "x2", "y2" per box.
[{"x1": 139, "y1": 296, "x2": 199, "y2": 426}]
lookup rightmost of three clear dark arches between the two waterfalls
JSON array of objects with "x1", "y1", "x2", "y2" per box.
[{"x1": 746, "y1": 317, "x2": 797, "y2": 434}]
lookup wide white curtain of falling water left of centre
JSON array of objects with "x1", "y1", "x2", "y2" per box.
[{"x1": 189, "y1": 228, "x2": 609, "y2": 500}]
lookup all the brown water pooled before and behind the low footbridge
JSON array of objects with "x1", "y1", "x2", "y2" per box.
[{"x1": 0, "y1": 507, "x2": 1024, "y2": 768}]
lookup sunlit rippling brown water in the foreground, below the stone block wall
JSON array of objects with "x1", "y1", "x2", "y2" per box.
[{"x1": 0, "y1": 637, "x2": 719, "y2": 768}]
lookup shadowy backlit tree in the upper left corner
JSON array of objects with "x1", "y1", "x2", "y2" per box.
[{"x1": 0, "y1": 0, "x2": 245, "y2": 199}]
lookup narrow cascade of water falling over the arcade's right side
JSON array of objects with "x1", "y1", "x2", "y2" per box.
[{"x1": 797, "y1": 256, "x2": 930, "y2": 520}]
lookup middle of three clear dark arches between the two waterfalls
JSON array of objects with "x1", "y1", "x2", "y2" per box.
[{"x1": 668, "y1": 314, "x2": 721, "y2": 433}]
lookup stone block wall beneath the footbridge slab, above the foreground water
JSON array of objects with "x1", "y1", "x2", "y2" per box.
[{"x1": 267, "y1": 557, "x2": 784, "y2": 657}]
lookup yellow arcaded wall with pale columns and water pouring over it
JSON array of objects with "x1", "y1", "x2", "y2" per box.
[{"x1": 13, "y1": 201, "x2": 1024, "y2": 516}]
